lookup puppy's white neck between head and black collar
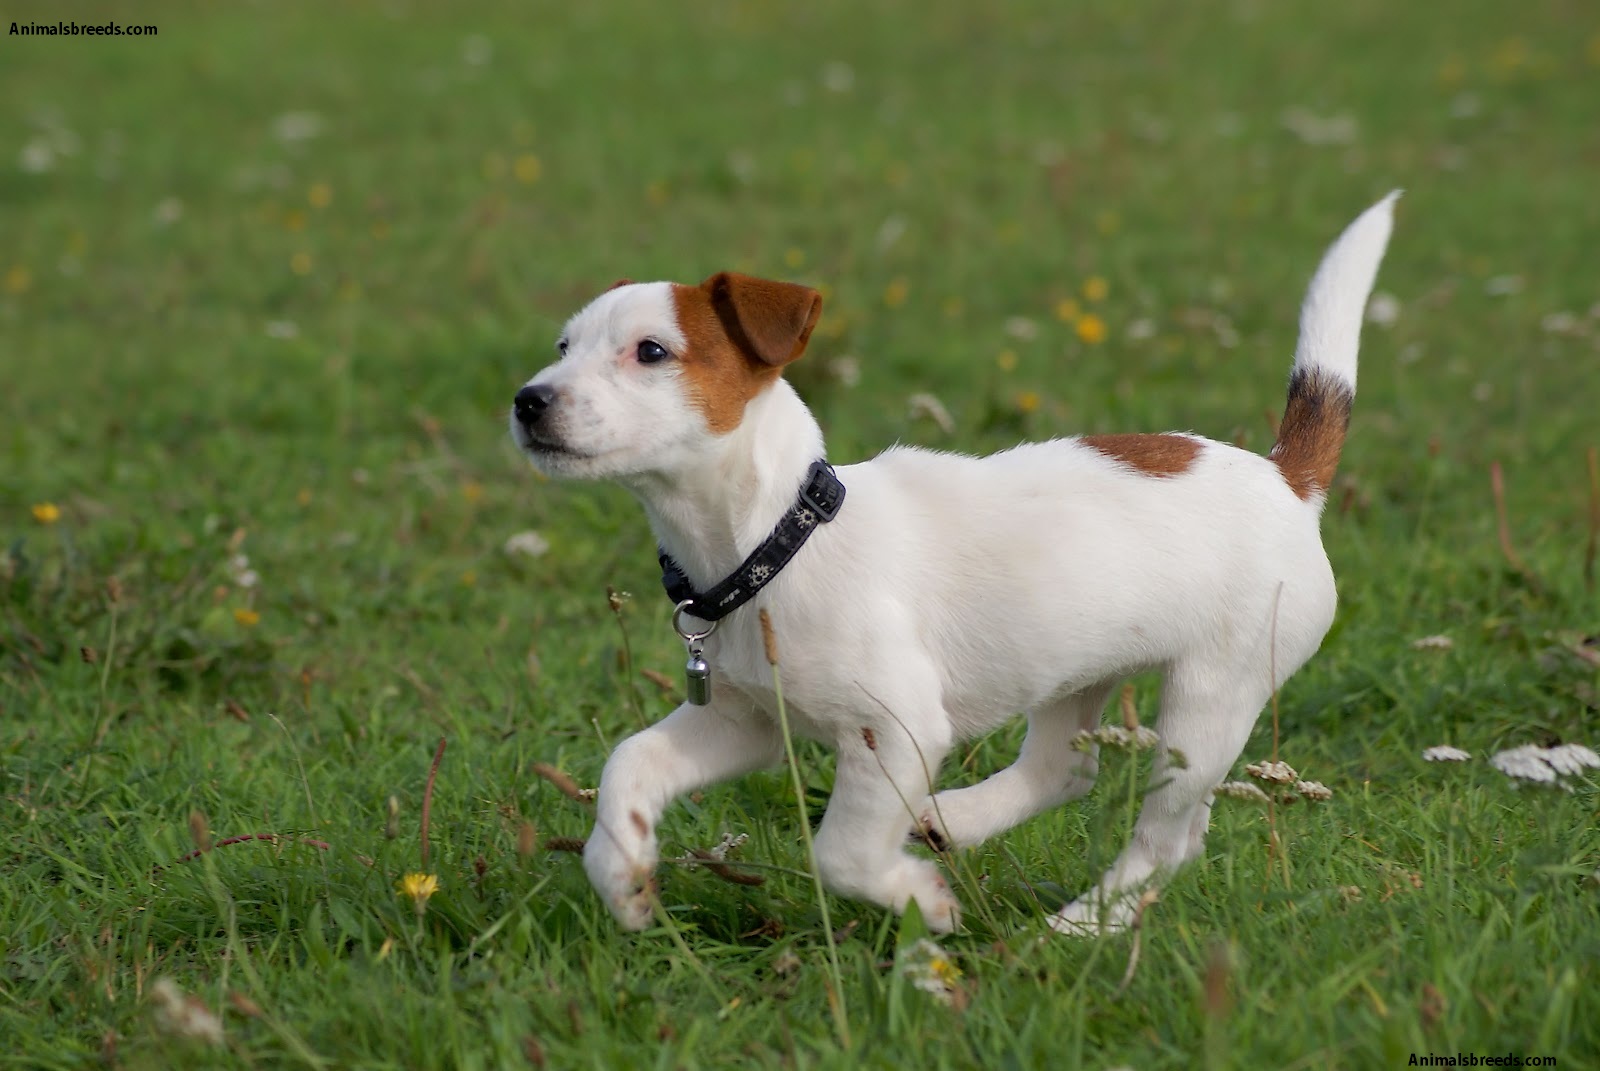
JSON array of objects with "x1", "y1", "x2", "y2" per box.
[{"x1": 626, "y1": 379, "x2": 822, "y2": 591}]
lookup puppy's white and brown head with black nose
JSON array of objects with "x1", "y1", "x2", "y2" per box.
[{"x1": 510, "y1": 272, "x2": 822, "y2": 479}]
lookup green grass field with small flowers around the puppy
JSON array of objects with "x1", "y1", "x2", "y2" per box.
[{"x1": 0, "y1": 0, "x2": 1600, "y2": 1069}]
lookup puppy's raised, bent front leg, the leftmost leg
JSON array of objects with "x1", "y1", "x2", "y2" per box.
[{"x1": 584, "y1": 701, "x2": 782, "y2": 930}]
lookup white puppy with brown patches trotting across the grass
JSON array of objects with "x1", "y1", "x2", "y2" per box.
[{"x1": 510, "y1": 191, "x2": 1398, "y2": 933}]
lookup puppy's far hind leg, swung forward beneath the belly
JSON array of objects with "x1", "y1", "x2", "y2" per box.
[{"x1": 912, "y1": 682, "x2": 1115, "y2": 850}]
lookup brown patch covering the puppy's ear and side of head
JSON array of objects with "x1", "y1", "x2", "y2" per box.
[{"x1": 672, "y1": 272, "x2": 822, "y2": 435}]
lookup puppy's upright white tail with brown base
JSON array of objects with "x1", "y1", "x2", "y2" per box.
[{"x1": 1267, "y1": 191, "x2": 1400, "y2": 509}]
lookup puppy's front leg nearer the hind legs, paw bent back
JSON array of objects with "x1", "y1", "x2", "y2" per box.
[{"x1": 816, "y1": 723, "x2": 962, "y2": 933}]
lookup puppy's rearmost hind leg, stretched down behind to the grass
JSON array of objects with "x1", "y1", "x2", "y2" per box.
[{"x1": 1050, "y1": 666, "x2": 1270, "y2": 935}]
